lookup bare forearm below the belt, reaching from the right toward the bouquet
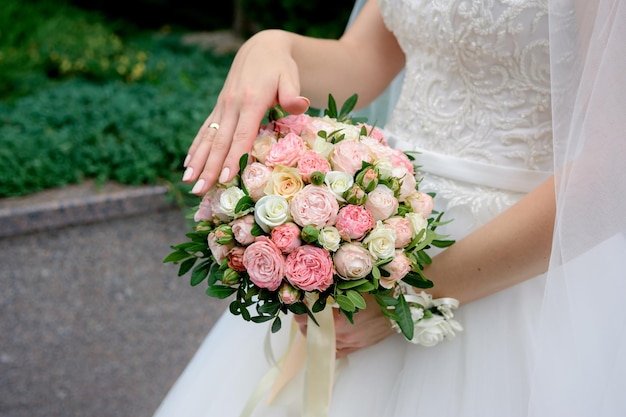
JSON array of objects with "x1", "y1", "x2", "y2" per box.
[{"x1": 425, "y1": 177, "x2": 556, "y2": 303}]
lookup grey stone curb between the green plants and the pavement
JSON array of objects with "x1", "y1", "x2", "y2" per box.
[{"x1": 0, "y1": 182, "x2": 176, "y2": 238}]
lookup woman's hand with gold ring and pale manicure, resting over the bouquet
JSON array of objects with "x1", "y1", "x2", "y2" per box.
[{"x1": 183, "y1": 30, "x2": 309, "y2": 195}]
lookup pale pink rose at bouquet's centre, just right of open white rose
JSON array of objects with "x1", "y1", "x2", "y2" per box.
[{"x1": 289, "y1": 184, "x2": 339, "y2": 229}]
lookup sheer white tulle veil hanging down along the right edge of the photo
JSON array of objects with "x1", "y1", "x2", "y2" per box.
[{"x1": 350, "y1": 0, "x2": 626, "y2": 417}]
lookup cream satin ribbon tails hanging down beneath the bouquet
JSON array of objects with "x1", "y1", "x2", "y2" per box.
[{"x1": 240, "y1": 306, "x2": 336, "y2": 417}]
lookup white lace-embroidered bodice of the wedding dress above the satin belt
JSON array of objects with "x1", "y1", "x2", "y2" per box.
[{"x1": 379, "y1": 0, "x2": 552, "y2": 171}]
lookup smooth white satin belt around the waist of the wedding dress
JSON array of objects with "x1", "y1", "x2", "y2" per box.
[{"x1": 387, "y1": 132, "x2": 552, "y2": 193}]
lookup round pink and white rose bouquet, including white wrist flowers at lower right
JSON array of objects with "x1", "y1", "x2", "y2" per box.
[{"x1": 163, "y1": 95, "x2": 460, "y2": 345}]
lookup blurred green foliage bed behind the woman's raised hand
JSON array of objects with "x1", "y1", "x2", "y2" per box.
[{"x1": 0, "y1": 0, "x2": 352, "y2": 198}]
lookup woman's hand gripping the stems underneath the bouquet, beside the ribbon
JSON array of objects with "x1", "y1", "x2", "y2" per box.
[{"x1": 294, "y1": 294, "x2": 395, "y2": 358}]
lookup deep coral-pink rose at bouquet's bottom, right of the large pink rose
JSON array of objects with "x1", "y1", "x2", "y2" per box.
[{"x1": 285, "y1": 245, "x2": 335, "y2": 291}]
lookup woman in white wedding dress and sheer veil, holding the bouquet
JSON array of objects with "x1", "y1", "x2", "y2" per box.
[{"x1": 155, "y1": 0, "x2": 626, "y2": 417}]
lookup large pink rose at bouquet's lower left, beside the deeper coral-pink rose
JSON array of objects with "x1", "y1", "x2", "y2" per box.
[{"x1": 243, "y1": 236, "x2": 285, "y2": 291}]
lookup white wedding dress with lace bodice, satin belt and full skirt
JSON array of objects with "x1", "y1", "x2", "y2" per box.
[{"x1": 155, "y1": 0, "x2": 626, "y2": 417}]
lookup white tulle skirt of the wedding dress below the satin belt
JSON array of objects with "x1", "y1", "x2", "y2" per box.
[{"x1": 154, "y1": 171, "x2": 560, "y2": 417}]
